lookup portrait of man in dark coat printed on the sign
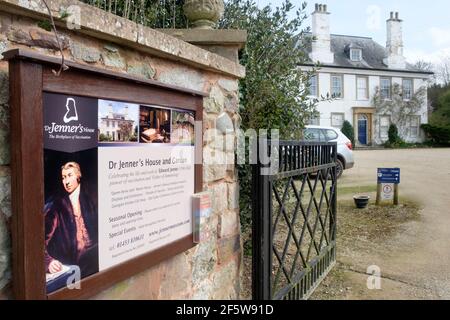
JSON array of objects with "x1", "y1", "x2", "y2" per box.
[{"x1": 44, "y1": 161, "x2": 98, "y2": 292}]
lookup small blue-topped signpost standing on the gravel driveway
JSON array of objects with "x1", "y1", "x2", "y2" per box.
[{"x1": 376, "y1": 168, "x2": 400, "y2": 206}]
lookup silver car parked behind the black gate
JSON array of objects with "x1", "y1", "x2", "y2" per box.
[{"x1": 303, "y1": 126, "x2": 355, "y2": 178}]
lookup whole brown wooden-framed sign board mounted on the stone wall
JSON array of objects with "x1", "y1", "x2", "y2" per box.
[{"x1": 3, "y1": 49, "x2": 205, "y2": 299}]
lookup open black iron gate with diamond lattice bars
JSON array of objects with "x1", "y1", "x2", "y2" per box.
[{"x1": 252, "y1": 140, "x2": 337, "y2": 300}]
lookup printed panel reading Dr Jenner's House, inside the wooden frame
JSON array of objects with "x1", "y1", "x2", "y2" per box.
[{"x1": 43, "y1": 93, "x2": 195, "y2": 293}]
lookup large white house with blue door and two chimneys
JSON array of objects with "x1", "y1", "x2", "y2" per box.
[{"x1": 301, "y1": 4, "x2": 432, "y2": 146}]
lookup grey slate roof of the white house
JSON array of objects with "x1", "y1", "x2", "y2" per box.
[{"x1": 303, "y1": 33, "x2": 433, "y2": 74}]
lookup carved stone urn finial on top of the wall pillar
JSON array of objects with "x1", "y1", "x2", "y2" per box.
[{"x1": 183, "y1": 0, "x2": 224, "y2": 29}]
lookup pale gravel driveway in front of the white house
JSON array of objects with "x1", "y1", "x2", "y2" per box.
[{"x1": 340, "y1": 149, "x2": 450, "y2": 299}]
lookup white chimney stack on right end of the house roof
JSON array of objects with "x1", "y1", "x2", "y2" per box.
[{"x1": 384, "y1": 12, "x2": 406, "y2": 69}]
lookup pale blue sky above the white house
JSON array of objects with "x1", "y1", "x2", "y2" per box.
[{"x1": 254, "y1": 0, "x2": 450, "y2": 64}]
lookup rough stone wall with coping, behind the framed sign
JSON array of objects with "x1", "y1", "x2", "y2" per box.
[{"x1": 0, "y1": 0, "x2": 244, "y2": 299}]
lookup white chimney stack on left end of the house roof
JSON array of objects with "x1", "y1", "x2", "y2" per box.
[{"x1": 310, "y1": 3, "x2": 334, "y2": 64}]
